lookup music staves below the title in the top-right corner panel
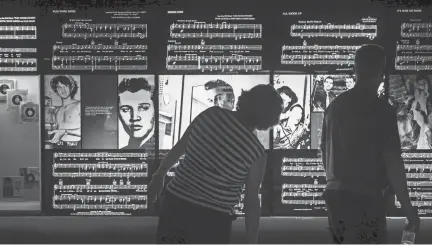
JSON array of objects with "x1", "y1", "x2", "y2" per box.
[{"x1": 395, "y1": 23, "x2": 432, "y2": 71}]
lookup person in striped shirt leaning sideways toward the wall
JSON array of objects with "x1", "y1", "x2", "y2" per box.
[{"x1": 148, "y1": 85, "x2": 283, "y2": 244}]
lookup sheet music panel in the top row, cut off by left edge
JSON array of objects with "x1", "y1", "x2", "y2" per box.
[{"x1": 0, "y1": 13, "x2": 38, "y2": 73}]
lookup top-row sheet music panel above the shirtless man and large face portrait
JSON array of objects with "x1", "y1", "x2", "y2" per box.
[{"x1": 42, "y1": 10, "x2": 149, "y2": 72}]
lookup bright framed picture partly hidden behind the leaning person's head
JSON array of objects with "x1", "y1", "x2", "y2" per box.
[{"x1": 180, "y1": 75, "x2": 270, "y2": 149}]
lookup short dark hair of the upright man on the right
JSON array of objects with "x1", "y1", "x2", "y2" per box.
[{"x1": 354, "y1": 44, "x2": 386, "y2": 79}]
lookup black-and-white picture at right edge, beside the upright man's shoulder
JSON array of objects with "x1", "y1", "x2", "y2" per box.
[{"x1": 389, "y1": 74, "x2": 432, "y2": 150}]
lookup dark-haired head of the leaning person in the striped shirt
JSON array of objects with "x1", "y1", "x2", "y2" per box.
[{"x1": 236, "y1": 85, "x2": 283, "y2": 130}]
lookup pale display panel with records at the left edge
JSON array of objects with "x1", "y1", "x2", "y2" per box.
[{"x1": 0, "y1": 76, "x2": 41, "y2": 211}]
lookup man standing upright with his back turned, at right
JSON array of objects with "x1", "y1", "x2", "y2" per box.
[{"x1": 321, "y1": 45, "x2": 420, "y2": 244}]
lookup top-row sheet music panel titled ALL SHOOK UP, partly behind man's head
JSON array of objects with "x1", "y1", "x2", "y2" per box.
[{"x1": 272, "y1": 1, "x2": 383, "y2": 73}]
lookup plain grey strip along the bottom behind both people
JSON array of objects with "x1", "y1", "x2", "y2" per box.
[{"x1": 0, "y1": 217, "x2": 432, "y2": 244}]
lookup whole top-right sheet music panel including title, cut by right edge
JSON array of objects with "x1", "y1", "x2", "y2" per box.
[{"x1": 388, "y1": 6, "x2": 432, "y2": 72}]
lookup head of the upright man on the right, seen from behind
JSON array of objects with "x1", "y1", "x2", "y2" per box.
[{"x1": 354, "y1": 44, "x2": 386, "y2": 90}]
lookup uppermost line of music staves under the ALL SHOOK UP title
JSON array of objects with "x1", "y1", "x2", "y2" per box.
[{"x1": 290, "y1": 23, "x2": 378, "y2": 40}]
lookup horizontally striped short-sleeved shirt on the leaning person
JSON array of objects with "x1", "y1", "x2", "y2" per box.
[{"x1": 167, "y1": 107, "x2": 265, "y2": 214}]
